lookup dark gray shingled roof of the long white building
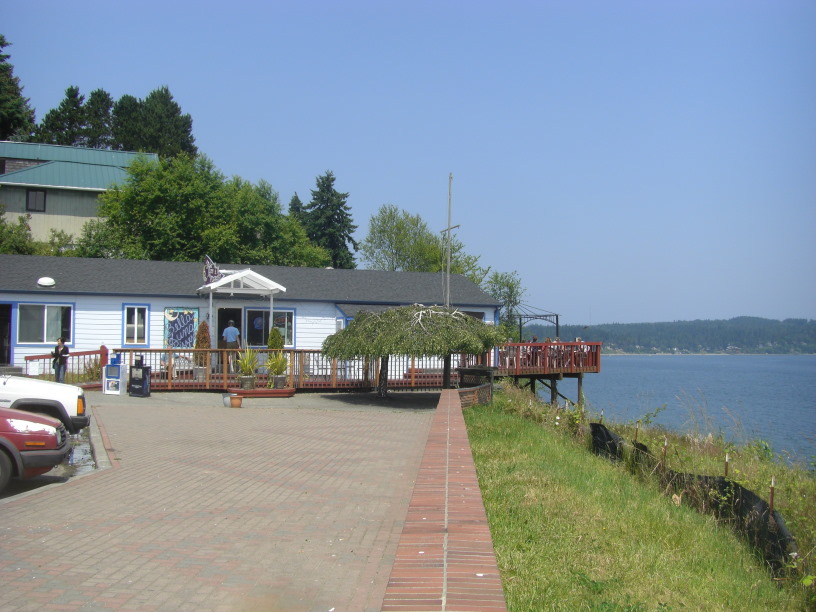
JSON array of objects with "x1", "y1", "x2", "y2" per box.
[{"x1": 0, "y1": 255, "x2": 500, "y2": 309}]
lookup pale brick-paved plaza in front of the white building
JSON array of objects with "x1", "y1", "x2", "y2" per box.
[{"x1": 0, "y1": 392, "x2": 503, "y2": 612}]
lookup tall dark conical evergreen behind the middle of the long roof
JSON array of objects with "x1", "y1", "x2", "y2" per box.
[{"x1": 303, "y1": 170, "x2": 357, "y2": 269}]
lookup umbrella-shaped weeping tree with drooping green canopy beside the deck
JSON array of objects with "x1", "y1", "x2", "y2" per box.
[{"x1": 323, "y1": 304, "x2": 504, "y2": 397}]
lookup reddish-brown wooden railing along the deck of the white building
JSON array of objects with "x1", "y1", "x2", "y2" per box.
[{"x1": 26, "y1": 342, "x2": 601, "y2": 391}]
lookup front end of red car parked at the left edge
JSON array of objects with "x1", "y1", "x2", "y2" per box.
[{"x1": 0, "y1": 408, "x2": 71, "y2": 491}]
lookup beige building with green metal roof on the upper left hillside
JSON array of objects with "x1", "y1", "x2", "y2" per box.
[{"x1": 0, "y1": 141, "x2": 158, "y2": 241}]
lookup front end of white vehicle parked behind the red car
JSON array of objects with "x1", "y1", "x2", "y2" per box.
[{"x1": 0, "y1": 374, "x2": 91, "y2": 433}]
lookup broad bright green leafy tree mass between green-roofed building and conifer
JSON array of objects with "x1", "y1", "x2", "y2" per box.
[{"x1": 77, "y1": 154, "x2": 329, "y2": 266}]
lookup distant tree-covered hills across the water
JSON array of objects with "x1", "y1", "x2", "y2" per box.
[{"x1": 524, "y1": 317, "x2": 816, "y2": 354}]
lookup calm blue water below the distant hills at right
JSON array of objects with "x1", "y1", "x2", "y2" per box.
[{"x1": 543, "y1": 355, "x2": 816, "y2": 461}]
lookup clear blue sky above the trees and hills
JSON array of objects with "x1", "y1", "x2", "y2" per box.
[{"x1": 0, "y1": 0, "x2": 816, "y2": 324}]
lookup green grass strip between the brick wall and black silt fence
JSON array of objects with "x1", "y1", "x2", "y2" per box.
[{"x1": 465, "y1": 393, "x2": 809, "y2": 610}]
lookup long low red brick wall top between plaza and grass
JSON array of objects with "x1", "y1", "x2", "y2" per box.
[{"x1": 382, "y1": 390, "x2": 507, "y2": 612}]
